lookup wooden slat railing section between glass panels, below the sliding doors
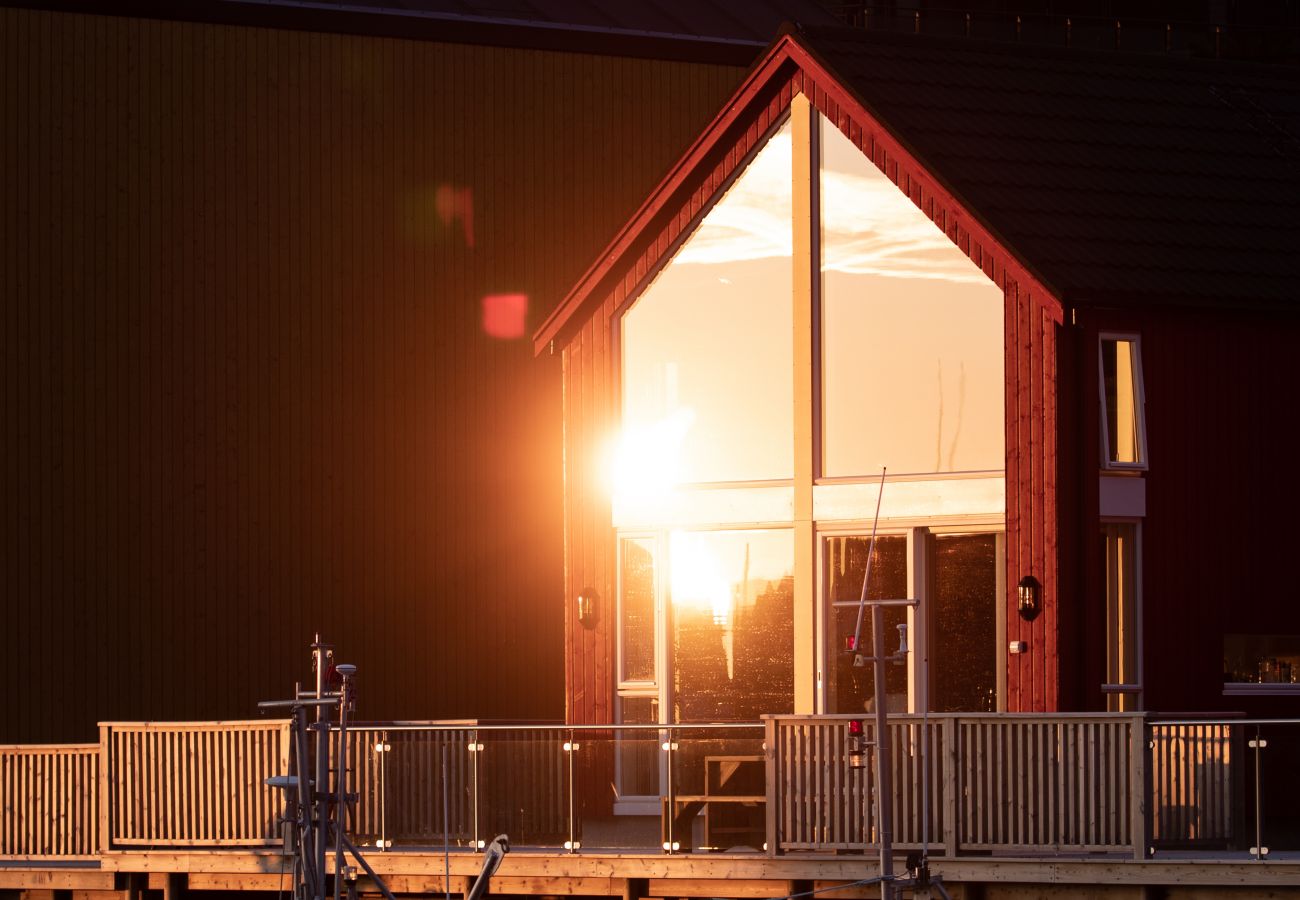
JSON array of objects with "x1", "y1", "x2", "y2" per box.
[{"x1": 768, "y1": 714, "x2": 1145, "y2": 854}]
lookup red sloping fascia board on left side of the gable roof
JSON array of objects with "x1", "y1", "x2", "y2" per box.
[{"x1": 533, "y1": 35, "x2": 790, "y2": 354}]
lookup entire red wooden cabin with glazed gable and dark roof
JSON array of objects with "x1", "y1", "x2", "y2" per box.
[{"x1": 536, "y1": 22, "x2": 1300, "y2": 738}]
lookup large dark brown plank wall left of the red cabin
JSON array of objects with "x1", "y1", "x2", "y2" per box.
[{"x1": 0, "y1": 9, "x2": 742, "y2": 741}]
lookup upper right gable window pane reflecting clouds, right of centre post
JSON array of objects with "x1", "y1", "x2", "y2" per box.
[{"x1": 820, "y1": 120, "x2": 1004, "y2": 476}]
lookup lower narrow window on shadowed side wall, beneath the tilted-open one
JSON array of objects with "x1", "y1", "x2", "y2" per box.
[{"x1": 1101, "y1": 522, "x2": 1141, "y2": 713}]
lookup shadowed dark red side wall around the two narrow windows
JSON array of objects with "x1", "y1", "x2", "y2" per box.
[{"x1": 1062, "y1": 307, "x2": 1300, "y2": 717}]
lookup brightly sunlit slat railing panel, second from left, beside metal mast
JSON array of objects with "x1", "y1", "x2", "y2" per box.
[{"x1": 100, "y1": 721, "x2": 289, "y2": 848}]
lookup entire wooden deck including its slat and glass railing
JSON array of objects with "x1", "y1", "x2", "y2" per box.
[{"x1": 0, "y1": 714, "x2": 1300, "y2": 900}]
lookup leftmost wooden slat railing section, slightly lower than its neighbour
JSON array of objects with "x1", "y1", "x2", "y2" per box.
[{"x1": 0, "y1": 744, "x2": 99, "y2": 858}]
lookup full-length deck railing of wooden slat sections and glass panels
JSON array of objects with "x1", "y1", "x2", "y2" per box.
[{"x1": 0, "y1": 714, "x2": 1284, "y2": 858}]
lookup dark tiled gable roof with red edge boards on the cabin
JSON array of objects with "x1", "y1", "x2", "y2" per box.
[{"x1": 536, "y1": 29, "x2": 1300, "y2": 350}]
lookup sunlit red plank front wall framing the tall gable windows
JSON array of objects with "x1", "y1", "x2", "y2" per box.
[{"x1": 560, "y1": 51, "x2": 1070, "y2": 723}]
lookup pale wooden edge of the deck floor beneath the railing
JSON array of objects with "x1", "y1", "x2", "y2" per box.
[{"x1": 0, "y1": 851, "x2": 1300, "y2": 900}]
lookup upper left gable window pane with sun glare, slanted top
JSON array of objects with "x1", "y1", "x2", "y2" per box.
[{"x1": 614, "y1": 124, "x2": 793, "y2": 493}]
